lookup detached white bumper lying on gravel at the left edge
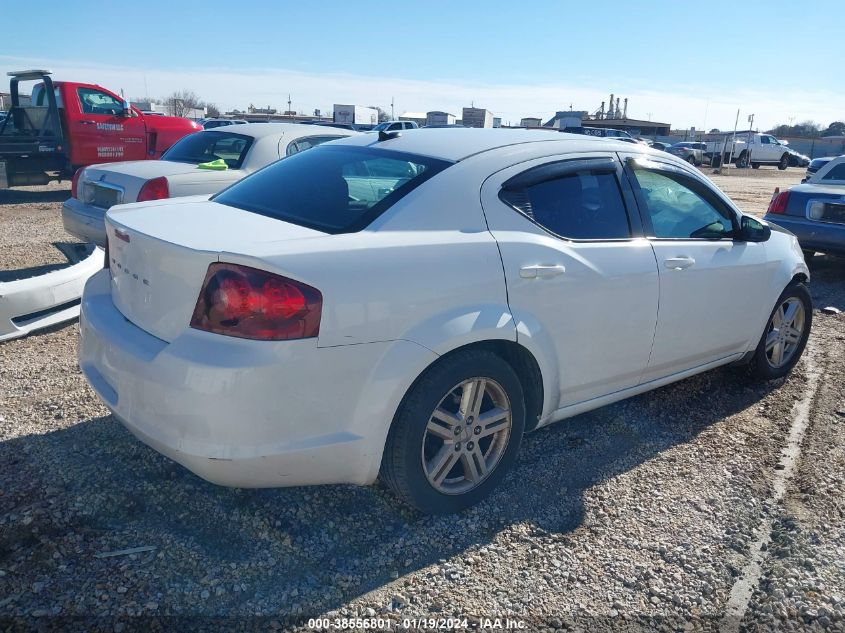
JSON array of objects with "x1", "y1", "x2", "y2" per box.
[{"x1": 0, "y1": 244, "x2": 103, "y2": 341}]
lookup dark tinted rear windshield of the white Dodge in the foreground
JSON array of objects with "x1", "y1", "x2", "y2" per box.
[{"x1": 213, "y1": 145, "x2": 451, "y2": 233}]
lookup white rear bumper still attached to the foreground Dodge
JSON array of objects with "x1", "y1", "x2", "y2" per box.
[{"x1": 79, "y1": 271, "x2": 436, "y2": 488}]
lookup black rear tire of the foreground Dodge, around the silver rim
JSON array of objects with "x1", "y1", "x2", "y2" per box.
[{"x1": 379, "y1": 350, "x2": 525, "y2": 514}]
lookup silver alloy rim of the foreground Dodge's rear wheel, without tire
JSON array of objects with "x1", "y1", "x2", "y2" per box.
[{"x1": 422, "y1": 377, "x2": 513, "y2": 495}]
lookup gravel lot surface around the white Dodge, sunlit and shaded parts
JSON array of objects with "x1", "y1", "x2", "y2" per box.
[{"x1": 0, "y1": 175, "x2": 845, "y2": 631}]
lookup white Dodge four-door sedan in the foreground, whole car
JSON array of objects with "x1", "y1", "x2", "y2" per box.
[{"x1": 79, "y1": 129, "x2": 812, "y2": 512}]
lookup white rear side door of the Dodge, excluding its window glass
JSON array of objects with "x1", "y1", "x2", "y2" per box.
[{"x1": 481, "y1": 151, "x2": 658, "y2": 408}]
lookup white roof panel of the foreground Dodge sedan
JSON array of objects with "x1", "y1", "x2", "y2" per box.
[{"x1": 324, "y1": 127, "x2": 620, "y2": 161}]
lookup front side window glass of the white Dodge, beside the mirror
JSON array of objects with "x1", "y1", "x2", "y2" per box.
[{"x1": 634, "y1": 168, "x2": 735, "y2": 239}]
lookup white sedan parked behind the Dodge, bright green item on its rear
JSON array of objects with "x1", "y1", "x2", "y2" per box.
[{"x1": 62, "y1": 123, "x2": 357, "y2": 246}]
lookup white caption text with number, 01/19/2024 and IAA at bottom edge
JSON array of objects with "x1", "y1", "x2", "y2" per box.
[{"x1": 308, "y1": 617, "x2": 526, "y2": 631}]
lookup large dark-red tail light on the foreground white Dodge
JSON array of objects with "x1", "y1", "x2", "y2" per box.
[{"x1": 191, "y1": 263, "x2": 323, "y2": 341}]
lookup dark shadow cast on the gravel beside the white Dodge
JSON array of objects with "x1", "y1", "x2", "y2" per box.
[{"x1": 0, "y1": 362, "x2": 781, "y2": 618}]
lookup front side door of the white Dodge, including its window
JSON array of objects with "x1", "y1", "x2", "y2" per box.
[{"x1": 626, "y1": 156, "x2": 777, "y2": 381}]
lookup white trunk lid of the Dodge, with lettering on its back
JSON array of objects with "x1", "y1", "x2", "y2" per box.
[{"x1": 106, "y1": 197, "x2": 325, "y2": 342}]
